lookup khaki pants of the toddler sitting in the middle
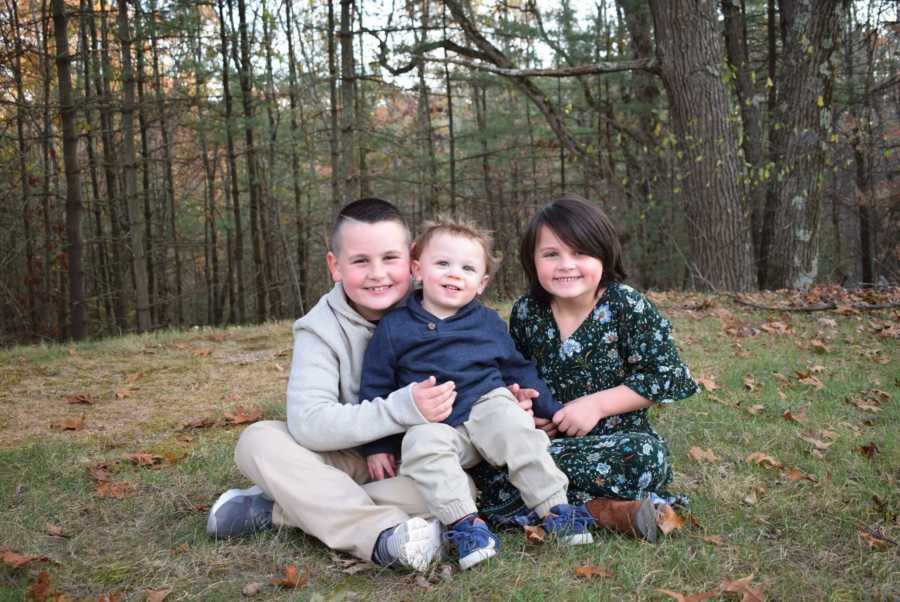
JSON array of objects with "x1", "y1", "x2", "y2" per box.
[{"x1": 400, "y1": 388, "x2": 569, "y2": 525}]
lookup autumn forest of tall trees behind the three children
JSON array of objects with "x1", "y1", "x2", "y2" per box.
[{"x1": 0, "y1": 0, "x2": 900, "y2": 344}]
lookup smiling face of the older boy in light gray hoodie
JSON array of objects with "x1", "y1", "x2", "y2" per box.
[{"x1": 325, "y1": 221, "x2": 410, "y2": 322}]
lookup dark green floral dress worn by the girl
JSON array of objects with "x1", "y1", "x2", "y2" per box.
[{"x1": 469, "y1": 283, "x2": 697, "y2": 524}]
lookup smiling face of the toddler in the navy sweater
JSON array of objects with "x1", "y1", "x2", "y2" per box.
[{"x1": 413, "y1": 232, "x2": 489, "y2": 319}]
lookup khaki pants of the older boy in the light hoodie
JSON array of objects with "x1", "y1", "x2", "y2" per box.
[{"x1": 234, "y1": 421, "x2": 475, "y2": 560}]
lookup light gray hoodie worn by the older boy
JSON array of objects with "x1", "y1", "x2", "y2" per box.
[{"x1": 287, "y1": 283, "x2": 427, "y2": 451}]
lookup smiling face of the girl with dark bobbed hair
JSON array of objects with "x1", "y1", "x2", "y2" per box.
[{"x1": 534, "y1": 226, "x2": 603, "y2": 303}]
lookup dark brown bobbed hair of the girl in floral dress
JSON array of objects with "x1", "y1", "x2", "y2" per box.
[{"x1": 519, "y1": 194, "x2": 627, "y2": 303}]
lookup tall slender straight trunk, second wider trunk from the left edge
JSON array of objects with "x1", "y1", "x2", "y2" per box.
[{"x1": 118, "y1": 0, "x2": 150, "y2": 332}]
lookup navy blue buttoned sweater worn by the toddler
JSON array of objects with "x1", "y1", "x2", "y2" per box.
[{"x1": 359, "y1": 291, "x2": 562, "y2": 456}]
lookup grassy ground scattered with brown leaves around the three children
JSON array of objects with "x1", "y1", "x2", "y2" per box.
[{"x1": 0, "y1": 293, "x2": 900, "y2": 601}]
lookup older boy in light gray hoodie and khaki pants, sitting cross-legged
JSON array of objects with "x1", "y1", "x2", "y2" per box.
[{"x1": 207, "y1": 198, "x2": 464, "y2": 570}]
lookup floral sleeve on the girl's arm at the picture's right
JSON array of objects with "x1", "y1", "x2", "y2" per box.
[{"x1": 614, "y1": 285, "x2": 697, "y2": 403}]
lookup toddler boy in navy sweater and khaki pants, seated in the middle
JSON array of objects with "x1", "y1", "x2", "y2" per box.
[{"x1": 360, "y1": 214, "x2": 593, "y2": 569}]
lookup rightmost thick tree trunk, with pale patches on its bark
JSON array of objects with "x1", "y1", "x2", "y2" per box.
[{"x1": 766, "y1": 0, "x2": 839, "y2": 288}]
